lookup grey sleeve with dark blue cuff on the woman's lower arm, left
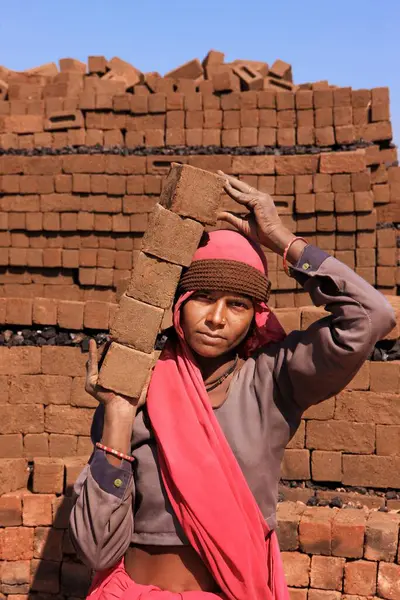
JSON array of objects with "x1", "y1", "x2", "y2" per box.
[{"x1": 69, "y1": 406, "x2": 135, "y2": 571}]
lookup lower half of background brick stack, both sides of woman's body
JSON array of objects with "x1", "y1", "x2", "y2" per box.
[{"x1": 0, "y1": 326, "x2": 400, "y2": 600}]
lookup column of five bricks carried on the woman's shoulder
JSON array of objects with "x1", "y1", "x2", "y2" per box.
[{"x1": 99, "y1": 165, "x2": 224, "y2": 398}]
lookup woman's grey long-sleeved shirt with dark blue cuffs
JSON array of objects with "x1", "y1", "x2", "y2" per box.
[{"x1": 70, "y1": 246, "x2": 395, "y2": 570}]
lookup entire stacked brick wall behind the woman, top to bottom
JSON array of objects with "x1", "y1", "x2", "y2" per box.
[{"x1": 0, "y1": 52, "x2": 400, "y2": 600}]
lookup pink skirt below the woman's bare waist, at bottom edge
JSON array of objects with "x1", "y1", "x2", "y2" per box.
[{"x1": 87, "y1": 559, "x2": 224, "y2": 600}]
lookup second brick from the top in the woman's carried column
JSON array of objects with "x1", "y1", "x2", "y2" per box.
[{"x1": 143, "y1": 205, "x2": 203, "y2": 266}]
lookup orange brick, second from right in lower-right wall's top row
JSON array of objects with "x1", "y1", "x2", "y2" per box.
[{"x1": 332, "y1": 509, "x2": 366, "y2": 558}]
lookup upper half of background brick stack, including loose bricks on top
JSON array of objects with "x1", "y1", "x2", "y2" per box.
[{"x1": 0, "y1": 52, "x2": 400, "y2": 308}]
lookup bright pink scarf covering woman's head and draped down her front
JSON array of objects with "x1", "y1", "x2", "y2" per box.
[{"x1": 147, "y1": 231, "x2": 289, "y2": 600}]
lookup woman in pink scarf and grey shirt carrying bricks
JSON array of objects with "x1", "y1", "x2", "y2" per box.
[{"x1": 70, "y1": 175, "x2": 395, "y2": 600}]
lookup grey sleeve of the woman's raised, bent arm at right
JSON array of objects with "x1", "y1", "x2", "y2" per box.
[{"x1": 258, "y1": 246, "x2": 396, "y2": 411}]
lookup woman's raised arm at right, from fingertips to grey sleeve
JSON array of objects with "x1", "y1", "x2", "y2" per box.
[{"x1": 220, "y1": 173, "x2": 396, "y2": 410}]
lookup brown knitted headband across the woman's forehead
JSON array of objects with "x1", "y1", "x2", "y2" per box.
[{"x1": 179, "y1": 259, "x2": 271, "y2": 302}]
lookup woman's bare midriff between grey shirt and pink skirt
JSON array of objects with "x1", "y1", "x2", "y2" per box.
[{"x1": 125, "y1": 545, "x2": 220, "y2": 593}]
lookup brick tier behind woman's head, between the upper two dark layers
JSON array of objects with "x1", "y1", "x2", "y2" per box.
[{"x1": 0, "y1": 146, "x2": 400, "y2": 308}]
